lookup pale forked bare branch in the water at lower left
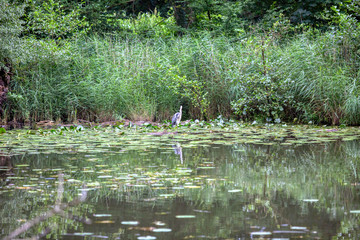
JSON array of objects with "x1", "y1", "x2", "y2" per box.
[{"x1": 3, "y1": 173, "x2": 91, "y2": 240}]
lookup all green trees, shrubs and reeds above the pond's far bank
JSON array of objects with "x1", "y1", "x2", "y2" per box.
[{"x1": 0, "y1": 0, "x2": 360, "y2": 125}]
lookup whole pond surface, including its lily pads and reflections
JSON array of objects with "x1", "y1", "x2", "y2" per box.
[{"x1": 0, "y1": 125, "x2": 360, "y2": 239}]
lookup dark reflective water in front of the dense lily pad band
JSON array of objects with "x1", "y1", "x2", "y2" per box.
[{"x1": 0, "y1": 141, "x2": 360, "y2": 239}]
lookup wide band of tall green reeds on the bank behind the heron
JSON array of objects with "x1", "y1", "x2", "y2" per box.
[{"x1": 7, "y1": 28, "x2": 360, "y2": 124}]
